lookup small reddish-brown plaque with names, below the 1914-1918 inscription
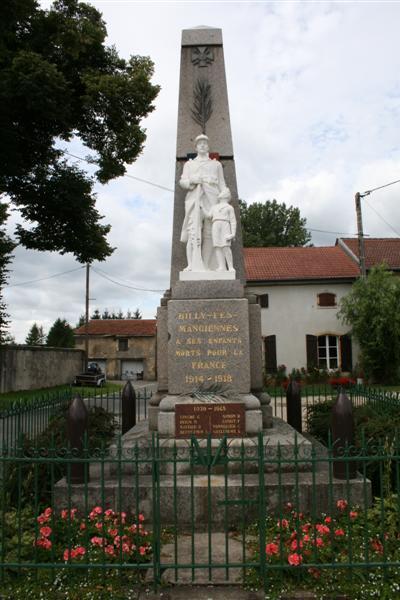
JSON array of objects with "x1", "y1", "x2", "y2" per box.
[{"x1": 175, "y1": 402, "x2": 245, "y2": 438}]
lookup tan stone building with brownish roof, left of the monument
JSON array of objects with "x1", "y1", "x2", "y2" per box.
[{"x1": 74, "y1": 319, "x2": 157, "y2": 380}]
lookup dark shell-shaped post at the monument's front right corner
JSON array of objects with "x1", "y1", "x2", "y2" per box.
[{"x1": 332, "y1": 390, "x2": 357, "y2": 479}]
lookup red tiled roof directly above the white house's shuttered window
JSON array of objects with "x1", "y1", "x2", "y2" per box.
[{"x1": 244, "y1": 246, "x2": 359, "y2": 281}]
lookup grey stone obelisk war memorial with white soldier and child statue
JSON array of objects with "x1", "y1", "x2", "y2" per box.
[{"x1": 57, "y1": 27, "x2": 364, "y2": 530}]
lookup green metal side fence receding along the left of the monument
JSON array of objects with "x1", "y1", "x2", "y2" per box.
[{"x1": 0, "y1": 388, "x2": 152, "y2": 446}]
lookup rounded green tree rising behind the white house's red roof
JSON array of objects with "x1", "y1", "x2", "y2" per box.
[{"x1": 239, "y1": 200, "x2": 311, "y2": 248}]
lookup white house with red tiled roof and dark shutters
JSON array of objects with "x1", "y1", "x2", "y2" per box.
[{"x1": 244, "y1": 238, "x2": 400, "y2": 373}]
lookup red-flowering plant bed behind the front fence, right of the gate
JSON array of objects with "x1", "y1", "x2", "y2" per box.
[{"x1": 245, "y1": 495, "x2": 400, "y2": 600}]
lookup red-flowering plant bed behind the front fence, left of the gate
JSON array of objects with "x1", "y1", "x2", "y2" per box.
[{"x1": 2, "y1": 506, "x2": 152, "y2": 579}]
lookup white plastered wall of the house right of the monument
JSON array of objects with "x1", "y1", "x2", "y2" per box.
[{"x1": 249, "y1": 283, "x2": 358, "y2": 372}]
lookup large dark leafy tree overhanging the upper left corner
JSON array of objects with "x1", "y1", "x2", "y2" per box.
[{"x1": 0, "y1": 0, "x2": 159, "y2": 260}]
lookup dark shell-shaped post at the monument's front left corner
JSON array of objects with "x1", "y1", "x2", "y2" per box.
[{"x1": 67, "y1": 394, "x2": 89, "y2": 483}]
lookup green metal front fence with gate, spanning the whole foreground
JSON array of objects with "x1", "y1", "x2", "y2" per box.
[{"x1": 0, "y1": 434, "x2": 400, "y2": 590}]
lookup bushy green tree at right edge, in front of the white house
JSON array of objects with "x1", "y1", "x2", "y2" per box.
[{"x1": 338, "y1": 265, "x2": 400, "y2": 384}]
